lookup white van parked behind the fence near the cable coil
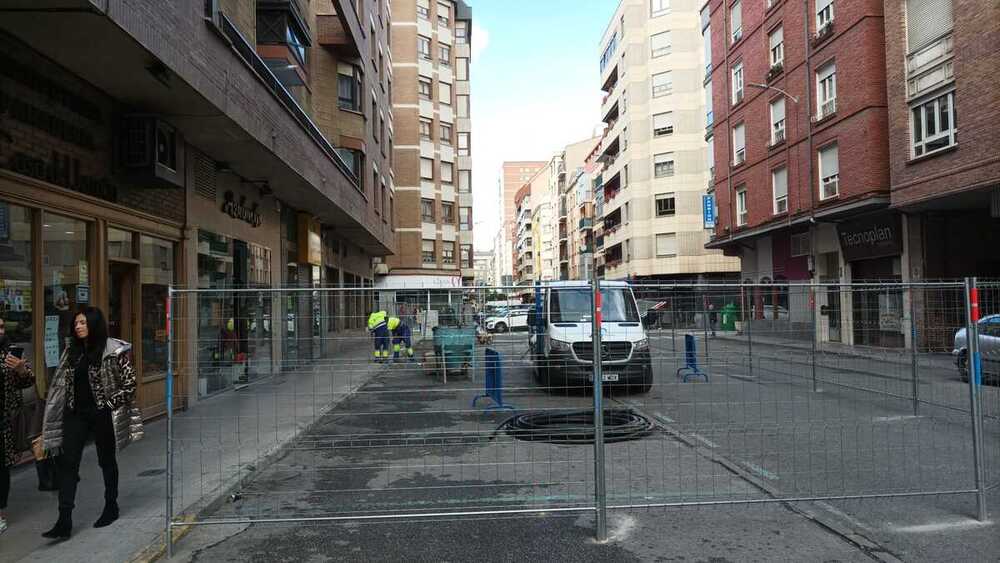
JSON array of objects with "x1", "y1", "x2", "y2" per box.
[{"x1": 528, "y1": 281, "x2": 653, "y2": 393}]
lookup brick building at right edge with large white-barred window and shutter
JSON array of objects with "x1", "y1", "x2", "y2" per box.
[{"x1": 884, "y1": 0, "x2": 1000, "y2": 279}]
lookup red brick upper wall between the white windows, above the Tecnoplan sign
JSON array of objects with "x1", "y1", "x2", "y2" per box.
[{"x1": 710, "y1": 0, "x2": 889, "y2": 237}]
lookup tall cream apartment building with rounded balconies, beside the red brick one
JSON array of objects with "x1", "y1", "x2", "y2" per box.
[{"x1": 598, "y1": 0, "x2": 739, "y2": 280}]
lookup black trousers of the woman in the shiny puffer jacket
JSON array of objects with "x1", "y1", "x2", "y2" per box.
[{"x1": 56, "y1": 409, "x2": 118, "y2": 513}]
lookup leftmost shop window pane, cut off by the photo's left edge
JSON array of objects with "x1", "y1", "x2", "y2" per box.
[{"x1": 0, "y1": 202, "x2": 33, "y2": 373}]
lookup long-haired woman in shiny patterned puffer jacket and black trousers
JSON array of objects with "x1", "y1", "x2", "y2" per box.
[{"x1": 42, "y1": 307, "x2": 135, "y2": 539}]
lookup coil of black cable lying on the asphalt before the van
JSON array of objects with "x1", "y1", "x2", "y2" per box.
[{"x1": 496, "y1": 409, "x2": 655, "y2": 444}]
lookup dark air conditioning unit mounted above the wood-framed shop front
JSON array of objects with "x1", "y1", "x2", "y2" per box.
[{"x1": 118, "y1": 115, "x2": 184, "y2": 188}]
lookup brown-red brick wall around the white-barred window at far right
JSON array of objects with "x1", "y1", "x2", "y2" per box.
[{"x1": 885, "y1": 0, "x2": 1000, "y2": 205}]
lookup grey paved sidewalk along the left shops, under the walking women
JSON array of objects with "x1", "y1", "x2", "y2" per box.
[{"x1": 0, "y1": 347, "x2": 384, "y2": 563}]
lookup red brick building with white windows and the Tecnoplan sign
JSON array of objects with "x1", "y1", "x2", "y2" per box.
[{"x1": 702, "y1": 0, "x2": 904, "y2": 346}]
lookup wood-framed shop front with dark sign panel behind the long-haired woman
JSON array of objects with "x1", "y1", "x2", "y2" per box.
[{"x1": 0, "y1": 30, "x2": 184, "y2": 438}]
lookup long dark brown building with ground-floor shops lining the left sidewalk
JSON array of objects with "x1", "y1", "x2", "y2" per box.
[{"x1": 0, "y1": 0, "x2": 396, "y2": 416}]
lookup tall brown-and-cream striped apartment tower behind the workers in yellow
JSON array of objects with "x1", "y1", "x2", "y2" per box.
[{"x1": 384, "y1": 0, "x2": 475, "y2": 289}]
